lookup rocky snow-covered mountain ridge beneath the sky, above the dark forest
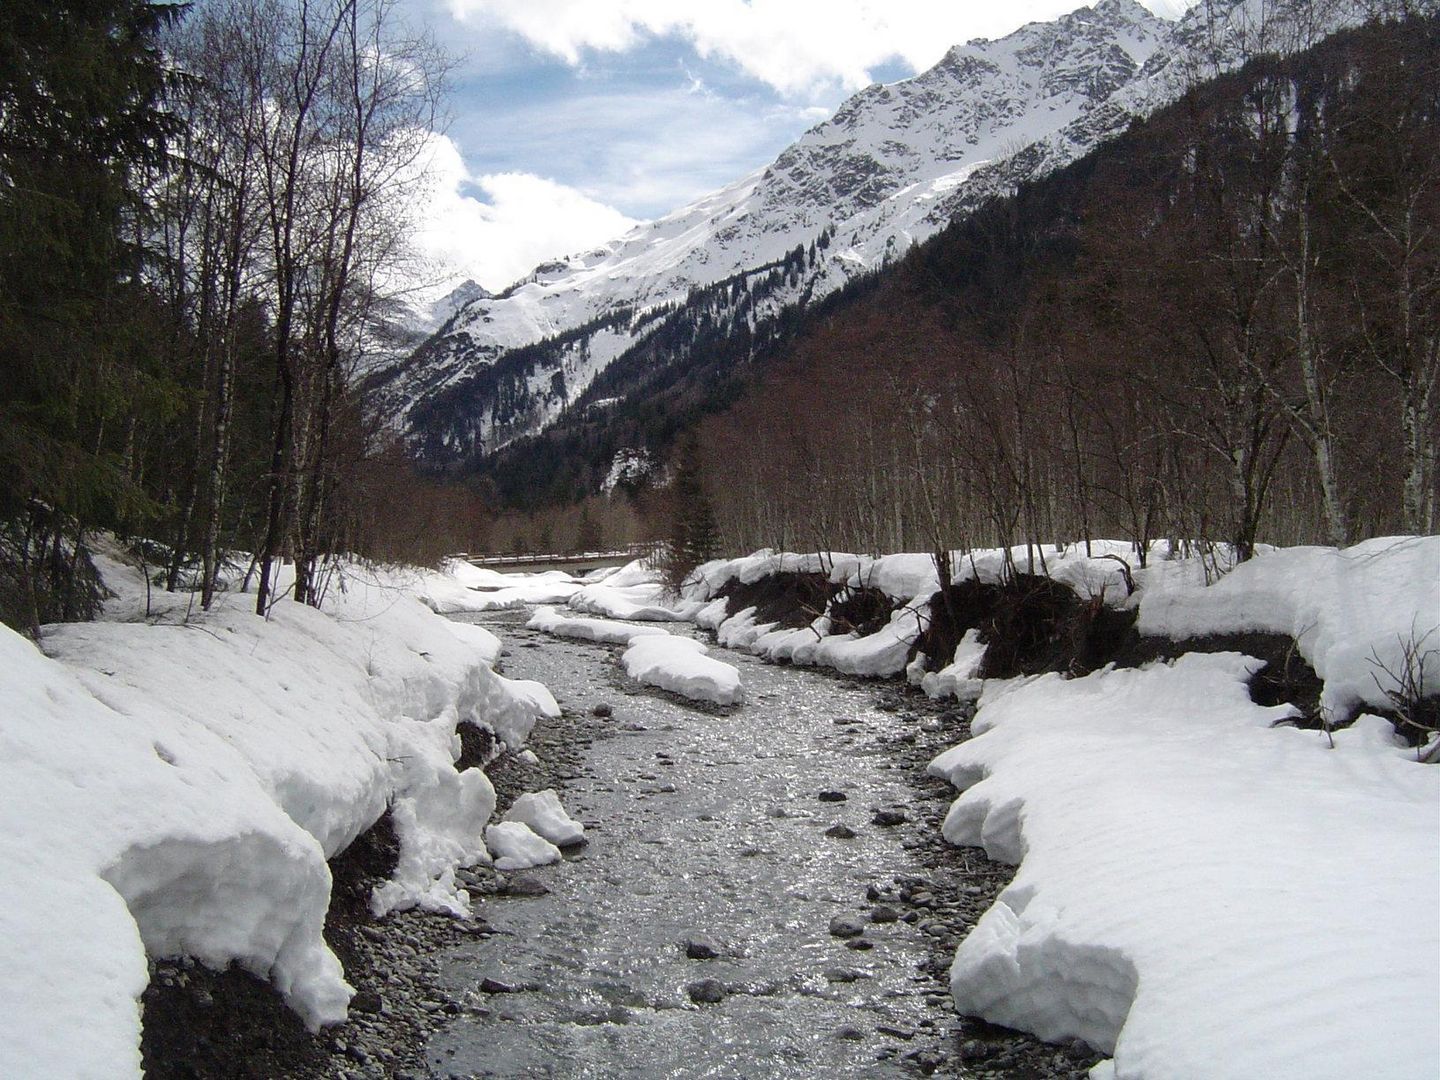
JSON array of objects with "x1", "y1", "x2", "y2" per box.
[{"x1": 372, "y1": 0, "x2": 1359, "y2": 464}]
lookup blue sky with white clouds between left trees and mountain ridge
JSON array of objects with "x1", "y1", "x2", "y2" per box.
[{"x1": 400, "y1": 0, "x2": 1182, "y2": 289}]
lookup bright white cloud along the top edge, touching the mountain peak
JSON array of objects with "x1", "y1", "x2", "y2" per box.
[{"x1": 449, "y1": 0, "x2": 1195, "y2": 96}]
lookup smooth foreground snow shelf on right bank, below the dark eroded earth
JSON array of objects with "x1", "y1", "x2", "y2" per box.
[{"x1": 932, "y1": 652, "x2": 1440, "y2": 1080}]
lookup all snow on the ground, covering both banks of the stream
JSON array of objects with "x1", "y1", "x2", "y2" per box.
[{"x1": 8, "y1": 537, "x2": 1440, "y2": 1079}]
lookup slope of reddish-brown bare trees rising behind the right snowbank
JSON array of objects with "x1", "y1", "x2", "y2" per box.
[{"x1": 704, "y1": 19, "x2": 1440, "y2": 553}]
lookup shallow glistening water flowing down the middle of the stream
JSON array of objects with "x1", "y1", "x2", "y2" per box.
[{"x1": 426, "y1": 622, "x2": 937, "y2": 1077}]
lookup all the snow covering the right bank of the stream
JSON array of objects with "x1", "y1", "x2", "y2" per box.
[{"x1": 685, "y1": 537, "x2": 1440, "y2": 1080}]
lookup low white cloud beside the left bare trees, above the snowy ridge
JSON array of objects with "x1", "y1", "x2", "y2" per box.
[{"x1": 413, "y1": 135, "x2": 635, "y2": 292}]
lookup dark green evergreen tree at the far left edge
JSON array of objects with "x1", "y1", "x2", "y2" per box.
[{"x1": 0, "y1": 0, "x2": 180, "y2": 629}]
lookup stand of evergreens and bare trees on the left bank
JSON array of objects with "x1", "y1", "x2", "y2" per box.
[{"x1": 0, "y1": 0, "x2": 449, "y2": 629}]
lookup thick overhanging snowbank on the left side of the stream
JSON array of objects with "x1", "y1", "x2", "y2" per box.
[{"x1": 0, "y1": 559, "x2": 557, "y2": 1077}]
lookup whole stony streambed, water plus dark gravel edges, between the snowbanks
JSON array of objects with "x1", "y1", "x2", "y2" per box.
[{"x1": 145, "y1": 615, "x2": 1097, "y2": 1079}]
